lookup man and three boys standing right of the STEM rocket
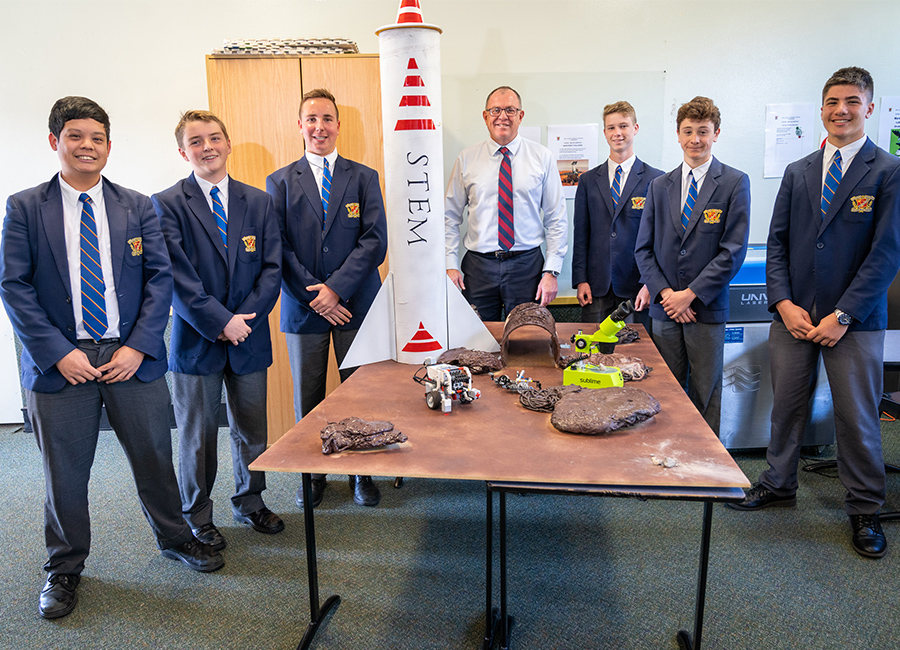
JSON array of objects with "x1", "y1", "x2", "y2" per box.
[{"x1": 445, "y1": 67, "x2": 900, "y2": 558}]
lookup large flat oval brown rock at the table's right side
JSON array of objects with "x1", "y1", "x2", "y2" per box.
[{"x1": 550, "y1": 386, "x2": 660, "y2": 435}]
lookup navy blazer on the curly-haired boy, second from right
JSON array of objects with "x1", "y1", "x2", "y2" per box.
[{"x1": 635, "y1": 157, "x2": 750, "y2": 323}]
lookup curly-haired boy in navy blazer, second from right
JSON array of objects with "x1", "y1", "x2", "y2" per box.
[{"x1": 635, "y1": 97, "x2": 750, "y2": 435}]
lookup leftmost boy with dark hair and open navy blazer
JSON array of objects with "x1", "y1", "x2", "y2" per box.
[{"x1": 0, "y1": 97, "x2": 224, "y2": 618}]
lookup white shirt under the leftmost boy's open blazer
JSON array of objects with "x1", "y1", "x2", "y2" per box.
[{"x1": 59, "y1": 174, "x2": 119, "y2": 340}]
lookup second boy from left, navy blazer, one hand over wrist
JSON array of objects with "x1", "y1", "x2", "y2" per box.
[{"x1": 152, "y1": 111, "x2": 284, "y2": 550}]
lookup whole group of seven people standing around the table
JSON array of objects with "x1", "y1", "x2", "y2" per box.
[{"x1": 0, "y1": 63, "x2": 900, "y2": 618}]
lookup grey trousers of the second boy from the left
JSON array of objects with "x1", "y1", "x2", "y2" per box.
[{"x1": 172, "y1": 367, "x2": 268, "y2": 528}]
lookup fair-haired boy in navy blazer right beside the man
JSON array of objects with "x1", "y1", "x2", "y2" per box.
[{"x1": 572, "y1": 102, "x2": 662, "y2": 331}]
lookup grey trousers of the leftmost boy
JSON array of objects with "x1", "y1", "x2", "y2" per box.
[{"x1": 25, "y1": 341, "x2": 193, "y2": 574}]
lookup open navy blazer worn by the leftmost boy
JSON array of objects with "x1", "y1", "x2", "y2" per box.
[{"x1": 0, "y1": 175, "x2": 172, "y2": 393}]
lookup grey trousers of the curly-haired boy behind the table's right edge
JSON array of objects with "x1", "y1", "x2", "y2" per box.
[{"x1": 650, "y1": 318, "x2": 725, "y2": 436}]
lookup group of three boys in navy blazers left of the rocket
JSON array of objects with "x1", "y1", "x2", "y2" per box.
[{"x1": 0, "y1": 89, "x2": 387, "y2": 619}]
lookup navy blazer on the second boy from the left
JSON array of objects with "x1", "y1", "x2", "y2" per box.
[{"x1": 152, "y1": 174, "x2": 281, "y2": 375}]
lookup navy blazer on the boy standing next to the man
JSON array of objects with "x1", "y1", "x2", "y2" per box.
[{"x1": 572, "y1": 159, "x2": 663, "y2": 298}]
